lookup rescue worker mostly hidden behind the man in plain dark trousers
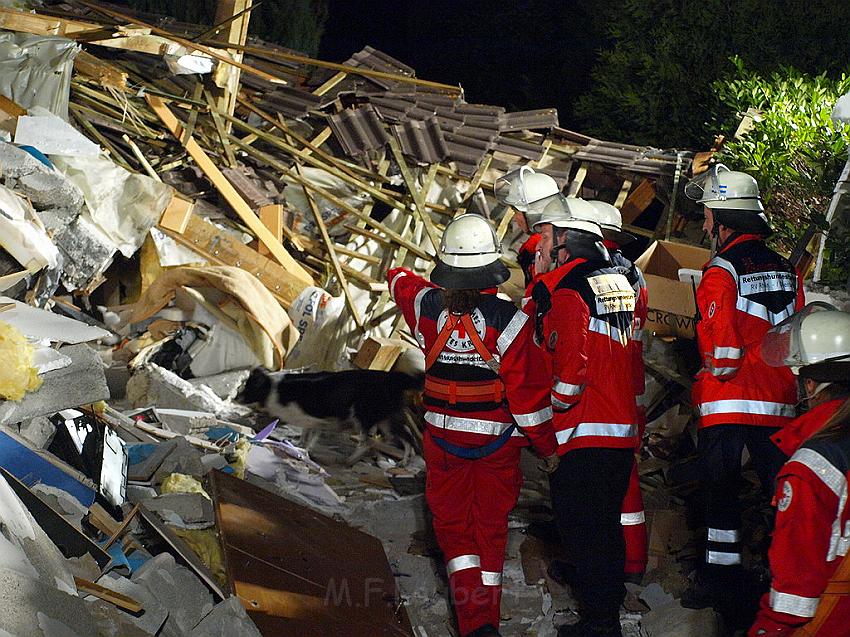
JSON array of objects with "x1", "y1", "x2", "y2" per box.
[{"x1": 590, "y1": 201, "x2": 649, "y2": 583}]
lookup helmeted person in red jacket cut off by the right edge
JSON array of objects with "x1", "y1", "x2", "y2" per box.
[{"x1": 748, "y1": 303, "x2": 850, "y2": 637}]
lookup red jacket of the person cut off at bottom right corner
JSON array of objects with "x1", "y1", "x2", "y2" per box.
[{"x1": 749, "y1": 418, "x2": 850, "y2": 637}]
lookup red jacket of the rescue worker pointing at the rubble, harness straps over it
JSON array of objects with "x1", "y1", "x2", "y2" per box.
[{"x1": 387, "y1": 268, "x2": 555, "y2": 456}]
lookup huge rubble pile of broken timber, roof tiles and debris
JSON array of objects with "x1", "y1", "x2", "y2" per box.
[{"x1": 0, "y1": 0, "x2": 728, "y2": 637}]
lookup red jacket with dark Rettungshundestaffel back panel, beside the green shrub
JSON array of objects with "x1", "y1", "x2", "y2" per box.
[{"x1": 692, "y1": 234, "x2": 804, "y2": 427}]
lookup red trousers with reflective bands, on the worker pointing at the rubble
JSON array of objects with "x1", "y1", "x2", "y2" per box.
[{"x1": 424, "y1": 431, "x2": 522, "y2": 635}]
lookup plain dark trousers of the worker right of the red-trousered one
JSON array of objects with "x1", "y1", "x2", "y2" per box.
[{"x1": 549, "y1": 448, "x2": 634, "y2": 618}]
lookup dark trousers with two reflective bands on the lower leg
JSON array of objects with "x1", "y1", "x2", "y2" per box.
[{"x1": 697, "y1": 425, "x2": 787, "y2": 579}]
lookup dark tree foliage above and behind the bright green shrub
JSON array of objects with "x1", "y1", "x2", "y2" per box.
[{"x1": 576, "y1": 0, "x2": 850, "y2": 148}]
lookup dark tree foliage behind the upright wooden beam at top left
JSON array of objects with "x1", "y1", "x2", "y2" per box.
[{"x1": 121, "y1": 0, "x2": 328, "y2": 56}]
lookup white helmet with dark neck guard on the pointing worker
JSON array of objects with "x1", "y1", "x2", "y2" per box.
[{"x1": 431, "y1": 213, "x2": 510, "y2": 290}]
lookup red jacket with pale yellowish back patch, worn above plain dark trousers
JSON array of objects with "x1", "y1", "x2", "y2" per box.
[{"x1": 525, "y1": 259, "x2": 638, "y2": 454}]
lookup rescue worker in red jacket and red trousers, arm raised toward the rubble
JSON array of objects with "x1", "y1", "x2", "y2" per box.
[{"x1": 387, "y1": 214, "x2": 558, "y2": 637}]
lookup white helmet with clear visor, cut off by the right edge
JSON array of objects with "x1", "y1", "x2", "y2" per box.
[{"x1": 761, "y1": 301, "x2": 850, "y2": 382}]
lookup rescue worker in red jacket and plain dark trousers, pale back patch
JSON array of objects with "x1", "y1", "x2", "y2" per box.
[{"x1": 525, "y1": 195, "x2": 638, "y2": 637}]
